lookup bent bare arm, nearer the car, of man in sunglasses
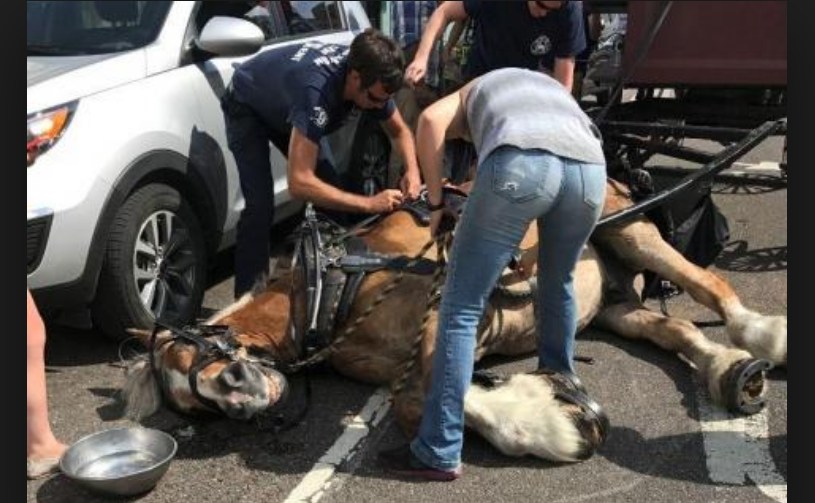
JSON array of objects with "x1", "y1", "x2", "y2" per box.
[{"x1": 287, "y1": 128, "x2": 402, "y2": 213}]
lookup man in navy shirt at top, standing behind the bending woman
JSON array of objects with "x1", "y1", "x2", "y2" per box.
[{"x1": 405, "y1": 0, "x2": 586, "y2": 91}]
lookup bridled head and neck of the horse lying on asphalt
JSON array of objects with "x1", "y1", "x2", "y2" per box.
[{"x1": 123, "y1": 280, "x2": 294, "y2": 419}]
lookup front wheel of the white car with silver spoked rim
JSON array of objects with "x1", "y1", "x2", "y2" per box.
[{"x1": 92, "y1": 184, "x2": 207, "y2": 340}]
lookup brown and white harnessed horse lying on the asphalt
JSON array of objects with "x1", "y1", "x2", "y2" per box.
[{"x1": 123, "y1": 180, "x2": 787, "y2": 461}]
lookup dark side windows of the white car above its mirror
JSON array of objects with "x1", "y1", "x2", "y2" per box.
[{"x1": 195, "y1": 1, "x2": 343, "y2": 42}]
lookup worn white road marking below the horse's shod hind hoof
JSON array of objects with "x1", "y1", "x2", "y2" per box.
[{"x1": 696, "y1": 390, "x2": 787, "y2": 503}]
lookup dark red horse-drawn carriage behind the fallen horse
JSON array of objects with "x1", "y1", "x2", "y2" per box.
[{"x1": 581, "y1": 0, "x2": 787, "y2": 297}]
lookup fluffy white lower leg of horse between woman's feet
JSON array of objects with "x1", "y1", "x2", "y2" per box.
[{"x1": 464, "y1": 374, "x2": 594, "y2": 462}]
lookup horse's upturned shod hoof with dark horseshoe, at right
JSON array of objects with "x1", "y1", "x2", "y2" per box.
[{"x1": 721, "y1": 358, "x2": 772, "y2": 415}]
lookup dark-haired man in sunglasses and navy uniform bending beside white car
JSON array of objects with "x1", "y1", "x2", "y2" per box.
[{"x1": 222, "y1": 29, "x2": 421, "y2": 298}]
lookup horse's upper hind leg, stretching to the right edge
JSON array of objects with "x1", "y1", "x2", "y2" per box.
[{"x1": 592, "y1": 218, "x2": 787, "y2": 365}]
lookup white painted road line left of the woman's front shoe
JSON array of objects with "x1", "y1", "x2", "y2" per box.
[{"x1": 284, "y1": 388, "x2": 391, "y2": 503}]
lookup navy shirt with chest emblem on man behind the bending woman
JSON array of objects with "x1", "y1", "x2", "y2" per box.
[{"x1": 464, "y1": 0, "x2": 586, "y2": 80}]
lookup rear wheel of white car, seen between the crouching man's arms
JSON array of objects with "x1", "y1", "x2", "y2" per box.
[{"x1": 349, "y1": 116, "x2": 396, "y2": 196}]
